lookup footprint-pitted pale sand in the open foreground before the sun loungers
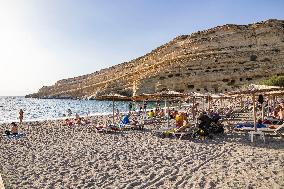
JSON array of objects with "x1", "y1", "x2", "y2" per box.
[{"x1": 0, "y1": 117, "x2": 284, "y2": 189}]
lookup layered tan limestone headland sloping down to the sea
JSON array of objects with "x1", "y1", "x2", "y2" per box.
[{"x1": 27, "y1": 20, "x2": 284, "y2": 98}]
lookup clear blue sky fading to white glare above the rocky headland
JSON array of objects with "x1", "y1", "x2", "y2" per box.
[{"x1": 0, "y1": 0, "x2": 284, "y2": 96}]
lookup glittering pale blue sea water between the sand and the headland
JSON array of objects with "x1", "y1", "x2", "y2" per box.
[{"x1": 0, "y1": 97, "x2": 129, "y2": 122}]
